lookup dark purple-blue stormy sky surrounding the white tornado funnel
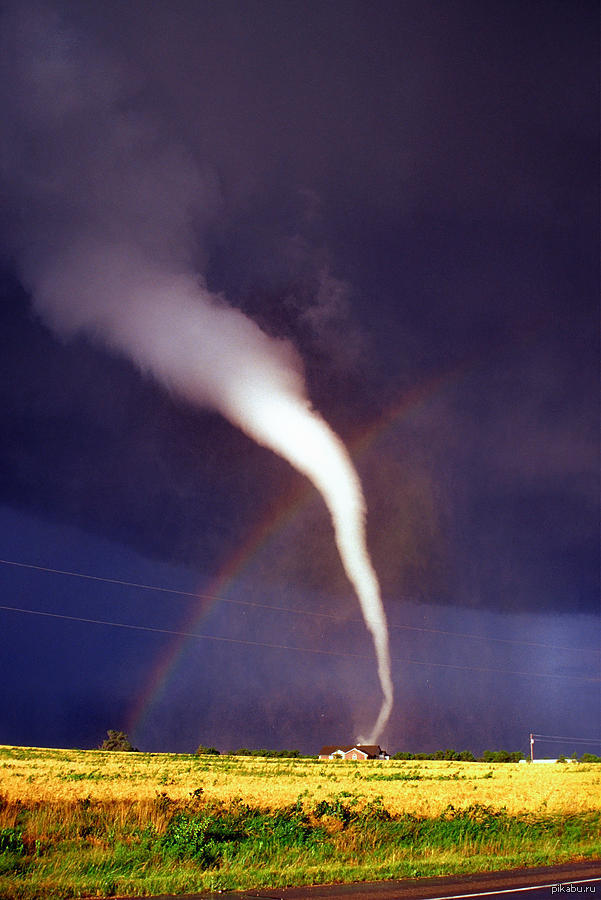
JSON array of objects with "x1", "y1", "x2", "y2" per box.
[{"x1": 0, "y1": 0, "x2": 601, "y2": 755}]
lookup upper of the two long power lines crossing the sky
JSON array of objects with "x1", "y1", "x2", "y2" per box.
[{"x1": 0, "y1": 559, "x2": 601, "y2": 653}]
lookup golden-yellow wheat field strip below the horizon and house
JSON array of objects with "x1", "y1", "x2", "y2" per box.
[{"x1": 0, "y1": 746, "x2": 601, "y2": 816}]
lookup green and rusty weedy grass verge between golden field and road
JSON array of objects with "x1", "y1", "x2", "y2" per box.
[{"x1": 0, "y1": 789, "x2": 601, "y2": 900}]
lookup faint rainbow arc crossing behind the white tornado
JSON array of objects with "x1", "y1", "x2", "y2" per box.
[{"x1": 127, "y1": 360, "x2": 473, "y2": 741}]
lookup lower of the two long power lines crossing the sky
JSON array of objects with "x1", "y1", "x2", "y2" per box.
[{"x1": 0, "y1": 605, "x2": 601, "y2": 683}]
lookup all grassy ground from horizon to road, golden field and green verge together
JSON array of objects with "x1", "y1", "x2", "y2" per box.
[{"x1": 0, "y1": 747, "x2": 601, "y2": 900}]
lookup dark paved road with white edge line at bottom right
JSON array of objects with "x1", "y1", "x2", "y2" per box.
[{"x1": 137, "y1": 860, "x2": 601, "y2": 900}]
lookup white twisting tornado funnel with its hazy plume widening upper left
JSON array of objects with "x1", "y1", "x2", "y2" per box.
[{"x1": 2, "y1": 3, "x2": 393, "y2": 743}]
